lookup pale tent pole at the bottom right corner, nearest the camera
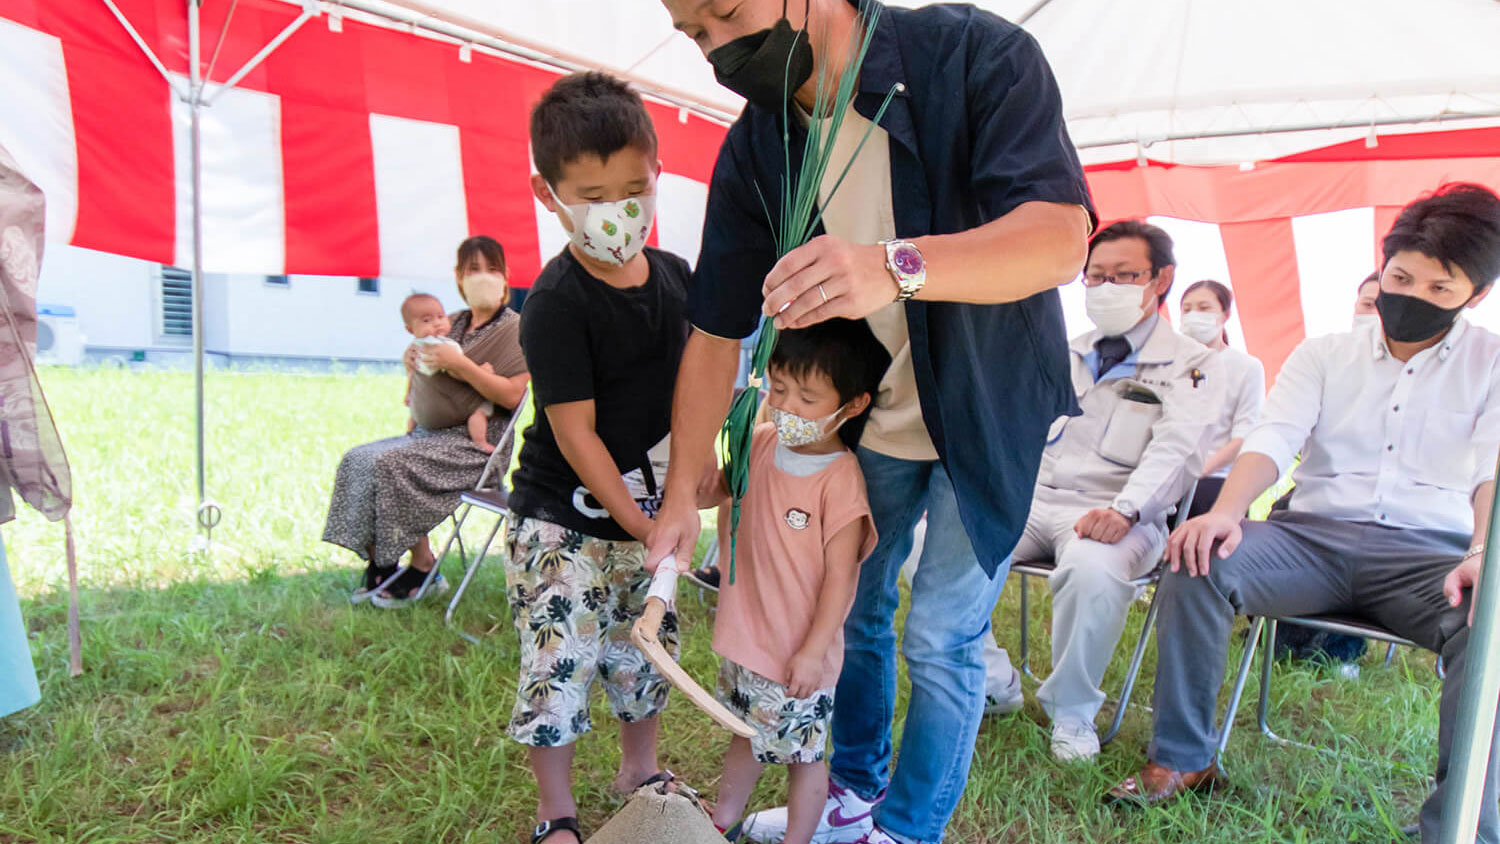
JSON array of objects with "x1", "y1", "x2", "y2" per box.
[{"x1": 1439, "y1": 461, "x2": 1500, "y2": 844}]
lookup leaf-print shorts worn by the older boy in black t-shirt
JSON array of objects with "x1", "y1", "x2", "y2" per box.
[{"x1": 506, "y1": 519, "x2": 678, "y2": 747}]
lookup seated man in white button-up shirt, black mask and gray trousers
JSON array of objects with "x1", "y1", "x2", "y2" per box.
[{"x1": 1110, "y1": 184, "x2": 1500, "y2": 844}]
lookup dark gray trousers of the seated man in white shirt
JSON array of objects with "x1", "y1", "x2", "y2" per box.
[{"x1": 1149, "y1": 513, "x2": 1500, "y2": 844}]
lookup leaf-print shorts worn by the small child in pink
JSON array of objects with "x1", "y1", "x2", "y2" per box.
[{"x1": 716, "y1": 658, "x2": 834, "y2": 765}]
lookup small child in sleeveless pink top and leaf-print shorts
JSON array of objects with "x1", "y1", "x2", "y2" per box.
[{"x1": 714, "y1": 319, "x2": 891, "y2": 844}]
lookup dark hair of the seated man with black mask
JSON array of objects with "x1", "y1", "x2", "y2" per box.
[{"x1": 1380, "y1": 181, "x2": 1500, "y2": 294}]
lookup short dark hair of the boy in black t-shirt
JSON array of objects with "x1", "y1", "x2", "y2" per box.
[{"x1": 531, "y1": 70, "x2": 657, "y2": 186}]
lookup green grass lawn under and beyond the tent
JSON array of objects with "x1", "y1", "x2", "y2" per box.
[{"x1": 0, "y1": 369, "x2": 1437, "y2": 844}]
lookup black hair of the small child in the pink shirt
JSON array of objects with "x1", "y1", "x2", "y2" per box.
[{"x1": 768, "y1": 318, "x2": 891, "y2": 448}]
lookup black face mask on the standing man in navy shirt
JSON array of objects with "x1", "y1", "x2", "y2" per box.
[{"x1": 708, "y1": 0, "x2": 813, "y2": 112}]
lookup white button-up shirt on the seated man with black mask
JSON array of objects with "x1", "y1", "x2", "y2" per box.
[{"x1": 1241, "y1": 318, "x2": 1500, "y2": 534}]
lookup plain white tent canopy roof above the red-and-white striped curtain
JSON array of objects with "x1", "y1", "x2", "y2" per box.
[{"x1": 392, "y1": 0, "x2": 1500, "y2": 163}]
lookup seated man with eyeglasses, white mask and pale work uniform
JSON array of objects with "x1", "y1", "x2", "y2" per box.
[{"x1": 987, "y1": 220, "x2": 1224, "y2": 762}]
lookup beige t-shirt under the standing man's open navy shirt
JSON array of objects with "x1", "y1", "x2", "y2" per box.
[{"x1": 818, "y1": 108, "x2": 938, "y2": 460}]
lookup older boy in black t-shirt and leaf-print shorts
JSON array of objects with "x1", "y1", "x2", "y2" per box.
[{"x1": 506, "y1": 73, "x2": 690, "y2": 844}]
